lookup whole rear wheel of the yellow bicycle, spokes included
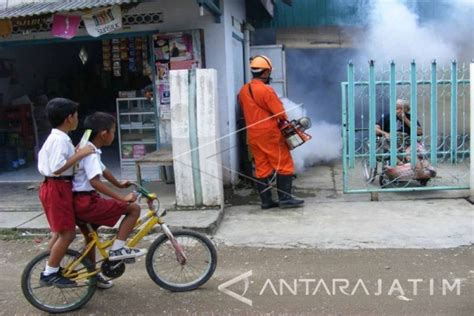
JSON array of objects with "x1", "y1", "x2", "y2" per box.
[{"x1": 21, "y1": 249, "x2": 96, "y2": 313}]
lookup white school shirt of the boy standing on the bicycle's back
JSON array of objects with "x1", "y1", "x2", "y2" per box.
[{"x1": 38, "y1": 128, "x2": 75, "y2": 177}]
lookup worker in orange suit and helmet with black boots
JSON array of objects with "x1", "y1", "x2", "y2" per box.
[{"x1": 238, "y1": 55, "x2": 304, "y2": 209}]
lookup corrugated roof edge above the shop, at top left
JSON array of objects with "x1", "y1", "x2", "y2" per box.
[{"x1": 0, "y1": 0, "x2": 138, "y2": 19}]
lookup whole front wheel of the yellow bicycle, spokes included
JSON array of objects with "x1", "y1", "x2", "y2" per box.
[{"x1": 146, "y1": 230, "x2": 217, "y2": 292}]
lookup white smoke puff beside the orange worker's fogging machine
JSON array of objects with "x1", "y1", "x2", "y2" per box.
[{"x1": 281, "y1": 98, "x2": 342, "y2": 172}]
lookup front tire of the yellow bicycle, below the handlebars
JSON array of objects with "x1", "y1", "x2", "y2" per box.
[{"x1": 146, "y1": 230, "x2": 217, "y2": 292}]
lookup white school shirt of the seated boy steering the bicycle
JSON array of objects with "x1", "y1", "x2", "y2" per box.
[{"x1": 72, "y1": 142, "x2": 105, "y2": 192}]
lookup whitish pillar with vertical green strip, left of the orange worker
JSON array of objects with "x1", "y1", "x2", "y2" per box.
[{"x1": 170, "y1": 69, "x2": 224, "y2": 208}]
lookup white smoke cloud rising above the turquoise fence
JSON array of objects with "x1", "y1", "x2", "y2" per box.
[{"x1": 357, "y1": 0, "x2": 474, "y2": 65}]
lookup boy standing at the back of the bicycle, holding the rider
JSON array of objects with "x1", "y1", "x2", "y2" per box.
[{"x1": 38, "y1": 98, "x2": 94, "y2": 288}]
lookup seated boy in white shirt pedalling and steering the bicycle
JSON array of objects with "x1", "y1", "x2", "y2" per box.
[{"x1": 73, "y1": 112, "x2": 146, "y2": 262}]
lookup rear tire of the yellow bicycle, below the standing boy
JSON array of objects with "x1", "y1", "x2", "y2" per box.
[{"x1": 21, "y1": 249, "x2": 97, "y2": 313}]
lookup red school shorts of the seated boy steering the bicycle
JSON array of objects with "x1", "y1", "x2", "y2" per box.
[{"x1": 74, "y1": 192, "x2": 128, "y2": 227}]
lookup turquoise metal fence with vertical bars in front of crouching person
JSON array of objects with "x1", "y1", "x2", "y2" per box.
[{"x1": 341, "y1": 61, "x2": 470, "y2": 193}]
